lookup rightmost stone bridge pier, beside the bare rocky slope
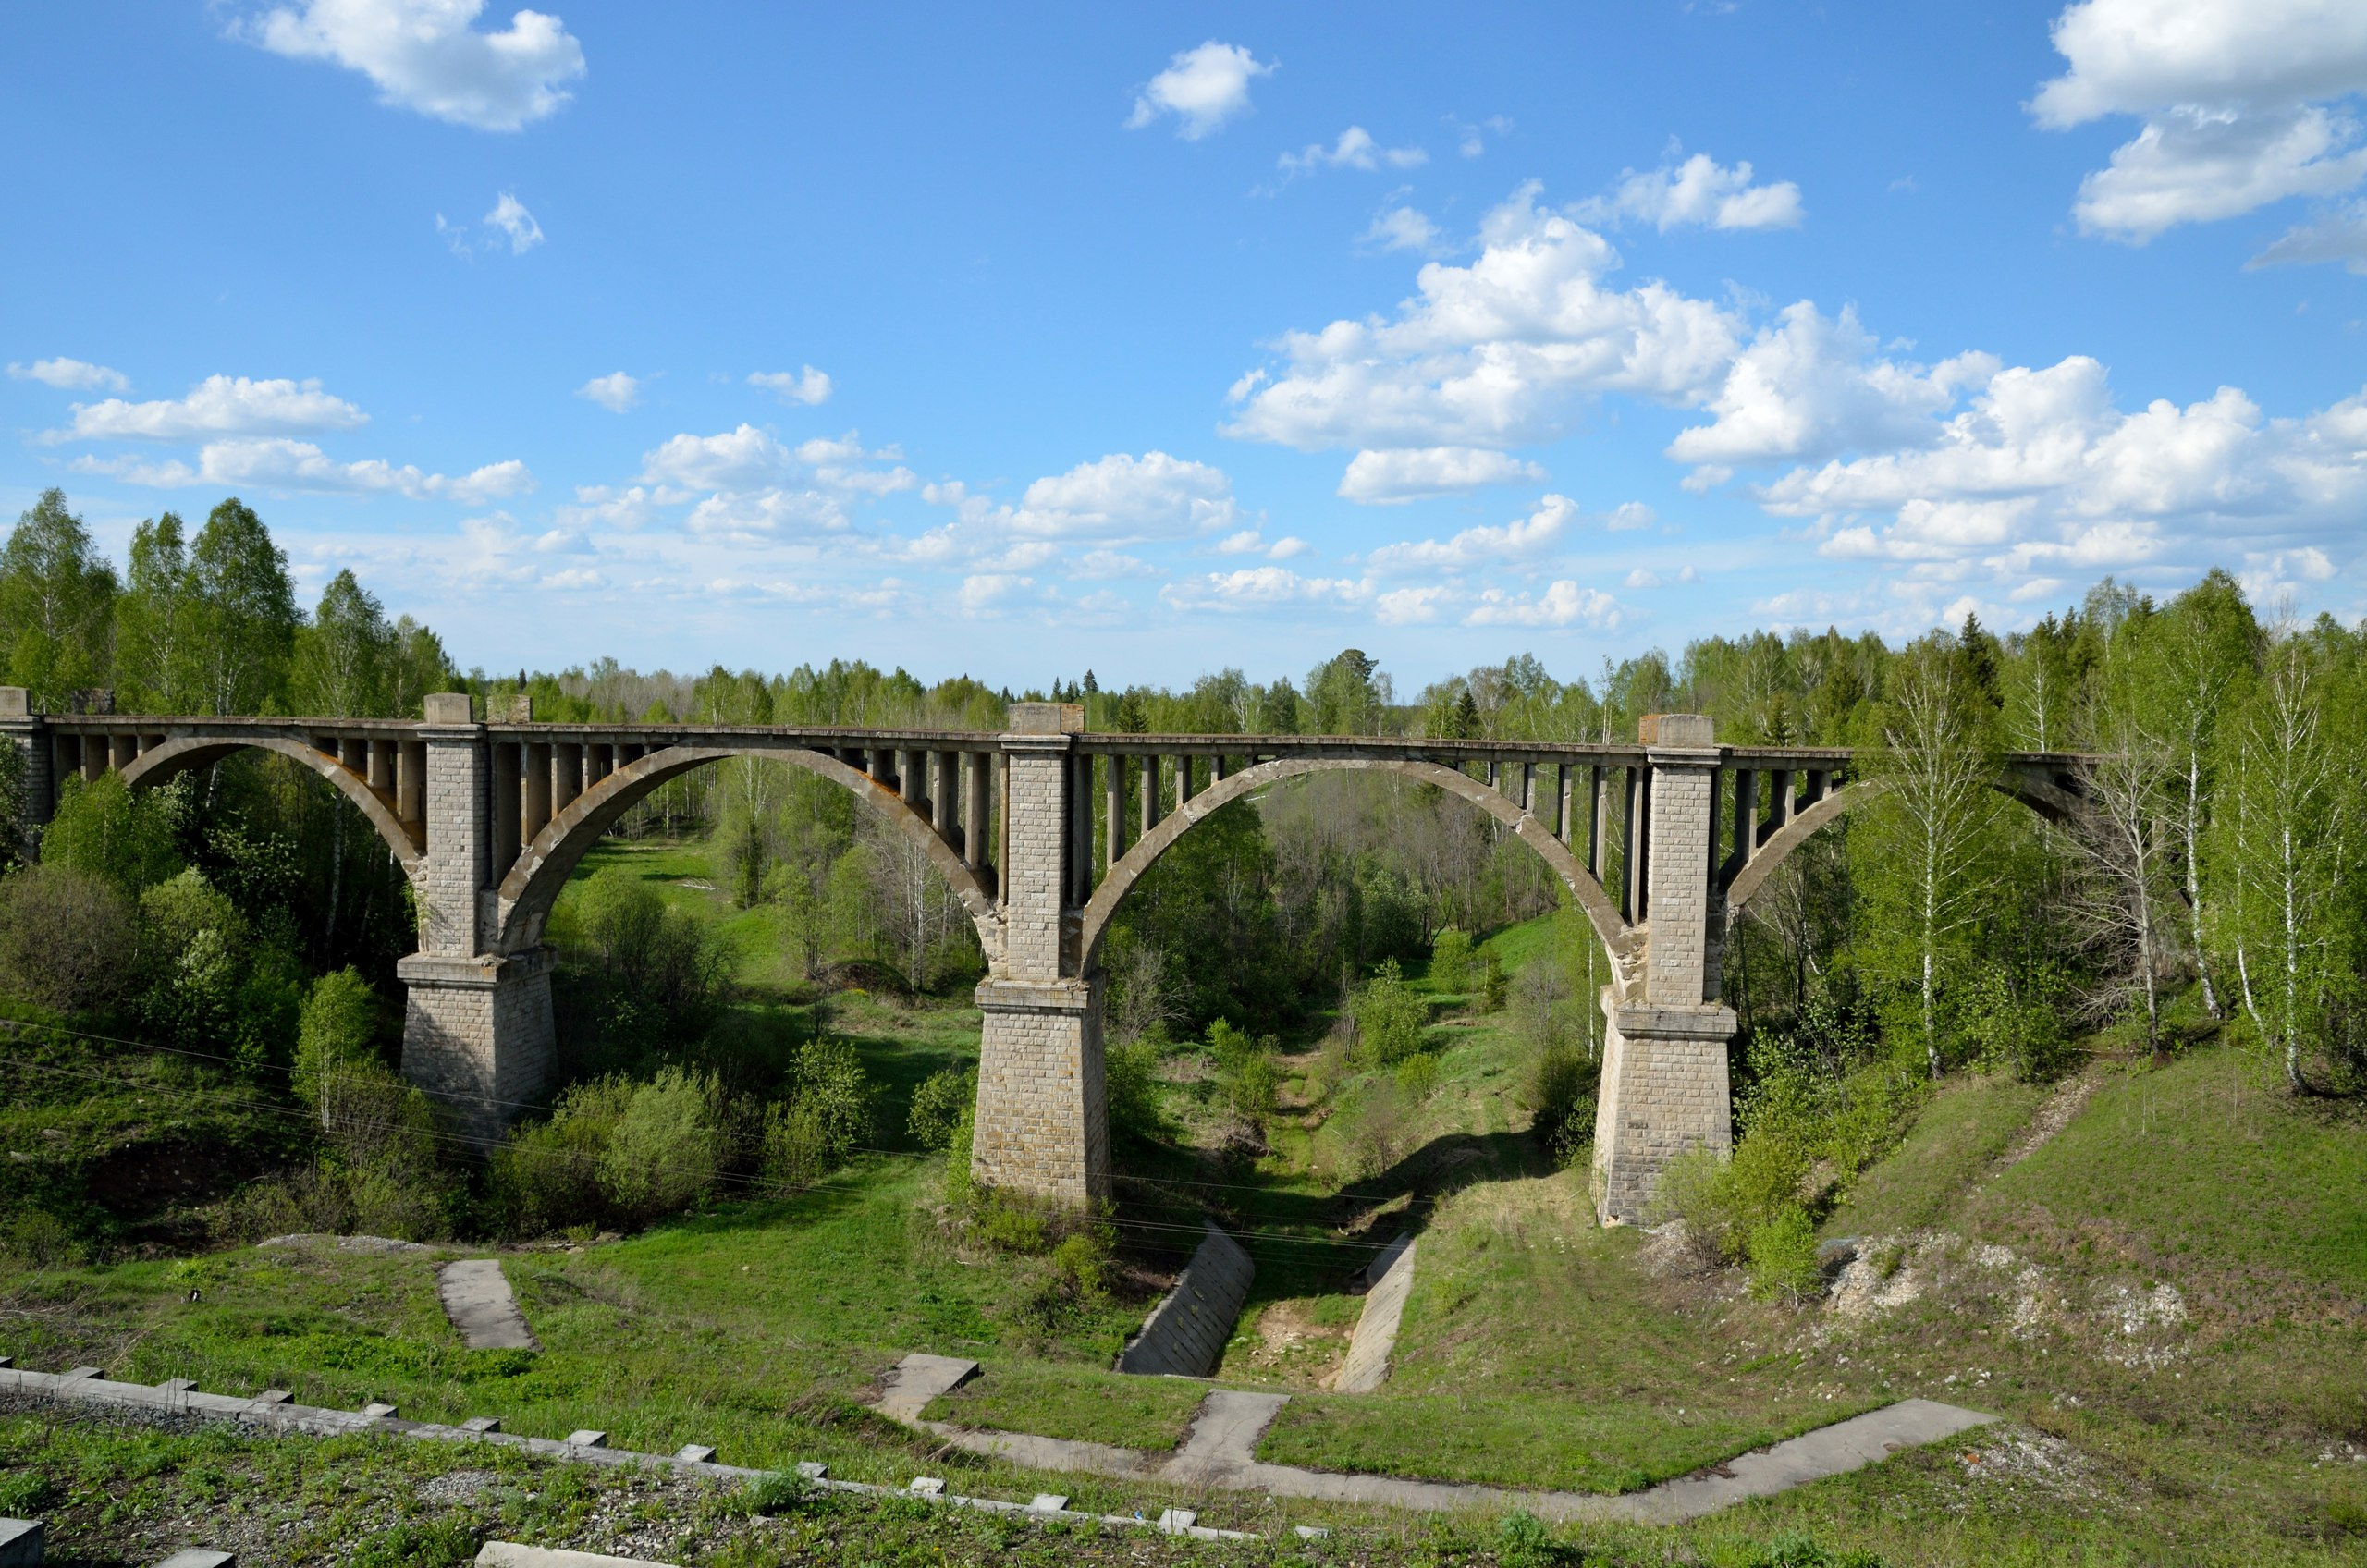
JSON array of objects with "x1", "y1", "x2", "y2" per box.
[{"x1": 1593, "y1": 713, "x2": 1735, "y2": 1222}]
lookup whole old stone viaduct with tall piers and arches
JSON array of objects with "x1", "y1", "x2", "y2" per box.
[{"x1": 0, "y1": 687, "x2": 2079, "y2": 1219}]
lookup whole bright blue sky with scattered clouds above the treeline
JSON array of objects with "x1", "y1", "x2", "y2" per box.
[{"x1": 0, "y1": 0, "x2": 2367, "y2": 684}]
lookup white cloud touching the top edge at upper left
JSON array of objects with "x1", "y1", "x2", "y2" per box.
[{"x1": 232, "y1": 0, "x2": 584, "y2": 130}]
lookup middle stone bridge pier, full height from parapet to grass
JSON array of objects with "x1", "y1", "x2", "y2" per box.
[{"x1": 971, "y1": 704, "x2": 1110, "y2": 1206}]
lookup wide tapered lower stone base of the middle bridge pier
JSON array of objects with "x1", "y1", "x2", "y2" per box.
[{"x1": 971, "y1": 976, "x2": 1110, "y2": 1208}]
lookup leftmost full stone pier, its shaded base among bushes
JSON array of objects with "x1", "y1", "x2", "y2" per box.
[{"x1": 396, "y1": 692, "x2": 554, "y2": 1149}]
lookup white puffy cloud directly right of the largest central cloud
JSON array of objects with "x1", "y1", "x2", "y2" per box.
[{"x1": 1669, "y1": 300, "x2": 1998, "y2": 464}]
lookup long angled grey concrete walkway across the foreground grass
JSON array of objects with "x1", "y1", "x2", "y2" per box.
[{"x1": 880, "y1": 1357, "x2": 1995, "y2": 1525}]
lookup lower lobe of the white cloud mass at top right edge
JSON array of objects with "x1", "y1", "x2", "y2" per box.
[{"x1": 2074, "y1": 104, "x2": 2367, "y2": 244}]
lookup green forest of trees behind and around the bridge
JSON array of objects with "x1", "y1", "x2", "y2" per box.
[{"x1": 0, "y1": 478, "x2": 2367, "y2": 1256}]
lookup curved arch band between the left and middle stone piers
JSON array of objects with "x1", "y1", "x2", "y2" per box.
[{"x1": 495, "y1": 743, "x2": 1001, "y2": 971}]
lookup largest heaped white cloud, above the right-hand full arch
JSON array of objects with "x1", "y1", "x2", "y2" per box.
[{"x1": 1226, "y1": 182, "x2": 1740, "y2": 450}]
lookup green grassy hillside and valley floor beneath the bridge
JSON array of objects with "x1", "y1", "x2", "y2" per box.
[{"x1": 0, "y1": 846, "x2": 2367, "y2": 1565}]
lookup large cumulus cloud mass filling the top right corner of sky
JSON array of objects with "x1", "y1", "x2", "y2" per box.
[{"x1": 2030, "y1": 0, "x2": 2367, "y2": 244}]
